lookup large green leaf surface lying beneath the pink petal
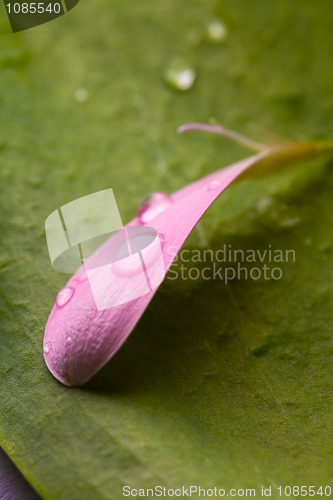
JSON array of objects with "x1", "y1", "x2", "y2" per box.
[{"x1": 0, "y1": 0, "x2": 333, "y2": 500}]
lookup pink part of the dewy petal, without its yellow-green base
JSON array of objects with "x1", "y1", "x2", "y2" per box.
[{"x1": 44, "y1": 153, "x2": 265, "y2": 386}]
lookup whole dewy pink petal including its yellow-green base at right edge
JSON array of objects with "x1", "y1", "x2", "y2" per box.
[{"x1": 44, "y1": 124, "x2": 332, "y2": 386}]
